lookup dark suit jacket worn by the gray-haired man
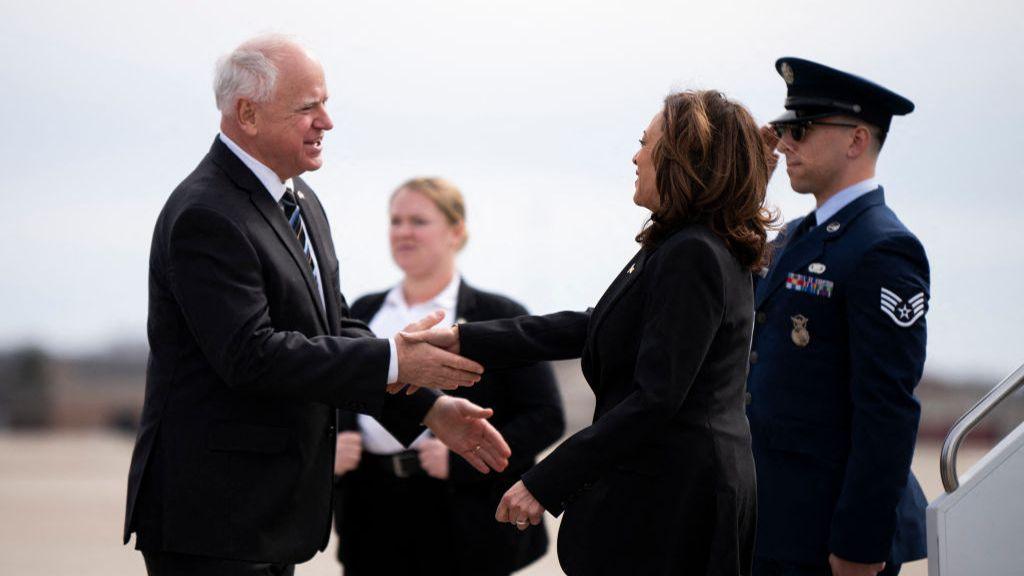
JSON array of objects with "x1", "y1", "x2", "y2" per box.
[{"x1": 124, "y1": 138, "x2": 435, "y2": 563}]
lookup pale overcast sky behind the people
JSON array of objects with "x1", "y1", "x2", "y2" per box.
[{"x1": 0, "y1": 0, "x2": 1024, "y2": 383}]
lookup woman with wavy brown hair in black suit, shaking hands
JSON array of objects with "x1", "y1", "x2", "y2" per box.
[{"x1": 407, "y1": 91, "x2": 774, "y2": 576}]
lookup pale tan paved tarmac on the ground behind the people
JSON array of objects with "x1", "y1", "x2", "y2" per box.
[{"x1": 0, "y1": 433, "x2": 984, "y2": 576}]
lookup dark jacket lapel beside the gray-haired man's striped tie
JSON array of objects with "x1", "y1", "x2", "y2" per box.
[{"x1": 210, "y1": 137, "x2": 330, "y2": 333}]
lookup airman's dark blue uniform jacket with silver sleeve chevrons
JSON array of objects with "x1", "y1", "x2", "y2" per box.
[{"x1": 748, "y1": 188, "x2": 929, "y2": 565}]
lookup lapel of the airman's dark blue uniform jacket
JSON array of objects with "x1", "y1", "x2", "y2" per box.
[{"x1": 755, "y1": 187, "x2": 885, "y2": 307}]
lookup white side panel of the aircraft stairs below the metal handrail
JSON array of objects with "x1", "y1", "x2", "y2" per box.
[{"x1": 928, "y1": 424, "x2": 1024, "y2": 576}]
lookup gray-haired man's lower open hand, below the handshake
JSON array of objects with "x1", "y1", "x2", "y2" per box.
[{"x1": 423, "y1": 396, "x2": 512, "y2": 474}]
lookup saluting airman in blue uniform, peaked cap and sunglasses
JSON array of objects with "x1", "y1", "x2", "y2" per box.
[{"x1": 748, "y1": 57, "x2": 929, "y2": 576}]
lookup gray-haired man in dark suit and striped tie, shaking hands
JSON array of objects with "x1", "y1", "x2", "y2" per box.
[{"x1": 124, "y1": 36, "x2": 509, "y2": 575}]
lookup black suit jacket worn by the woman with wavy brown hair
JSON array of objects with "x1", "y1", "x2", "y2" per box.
[{"x1": 460, "y1": 225, "x2": 756, "y2": 576}]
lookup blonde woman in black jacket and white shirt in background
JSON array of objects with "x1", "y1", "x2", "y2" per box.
[{"x1": 335, "y1": 177, "x2": 564, "y2": 576}]
